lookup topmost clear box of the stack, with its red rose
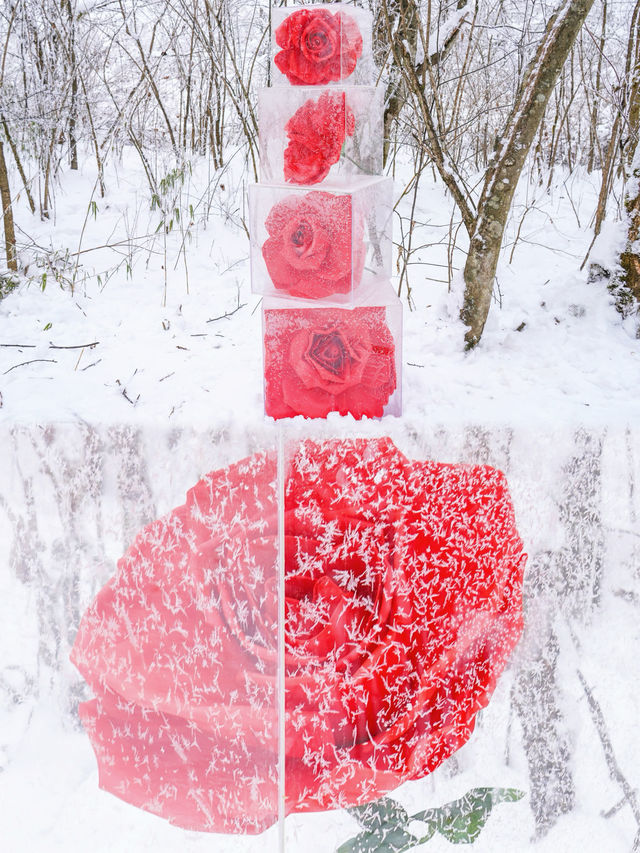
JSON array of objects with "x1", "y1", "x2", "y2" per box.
[{"x1": 271, "y1": 3, "x2": 376, "y2": 86}]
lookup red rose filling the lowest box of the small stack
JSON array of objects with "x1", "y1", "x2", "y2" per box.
[{"x1": 264, "y1": 308, "x2": 396, "y2": 418}]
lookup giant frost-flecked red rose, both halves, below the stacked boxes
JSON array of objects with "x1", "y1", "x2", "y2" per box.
[{"x1": 72, "y1": 439, "x2": 524, "y2": 832}]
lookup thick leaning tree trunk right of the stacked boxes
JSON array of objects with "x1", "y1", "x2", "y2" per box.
[{"x1": 460, "y1": 0, "x2": 593, "y2": 348}]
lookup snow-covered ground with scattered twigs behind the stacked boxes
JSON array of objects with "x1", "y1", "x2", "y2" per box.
[{"x1": 0, "y1": 153, "x2": 640, "y2": 424}]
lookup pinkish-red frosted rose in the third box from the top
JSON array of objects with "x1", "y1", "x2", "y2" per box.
[{"x1": 262, "y1": 190, "x2": 365, "y2": 299}]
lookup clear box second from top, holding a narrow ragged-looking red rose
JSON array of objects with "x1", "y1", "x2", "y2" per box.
[{"x1": 258, "y1": 86, "x2": 384, "y2": 186}]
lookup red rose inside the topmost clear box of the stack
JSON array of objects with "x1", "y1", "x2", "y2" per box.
[{"x1": 274, "y1": 9, "x2": 362, "y2": 86}]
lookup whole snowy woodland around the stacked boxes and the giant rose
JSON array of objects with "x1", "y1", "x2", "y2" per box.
[{"x1": 0, "y1": 0, "x2": 640, "y2": 853}]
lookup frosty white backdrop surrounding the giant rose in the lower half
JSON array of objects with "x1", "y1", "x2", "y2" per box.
[{"x1": 0, "y1": 418, "x2": 640, "y2": 853}]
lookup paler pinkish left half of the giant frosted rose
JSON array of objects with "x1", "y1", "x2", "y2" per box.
[{"x1": 71, "y1": 454, "x2": 278, "y2": 833}]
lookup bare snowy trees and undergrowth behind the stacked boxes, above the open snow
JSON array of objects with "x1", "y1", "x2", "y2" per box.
[{"x1": 0, "y1": 0, "x2": 640, "y2": 332}]
